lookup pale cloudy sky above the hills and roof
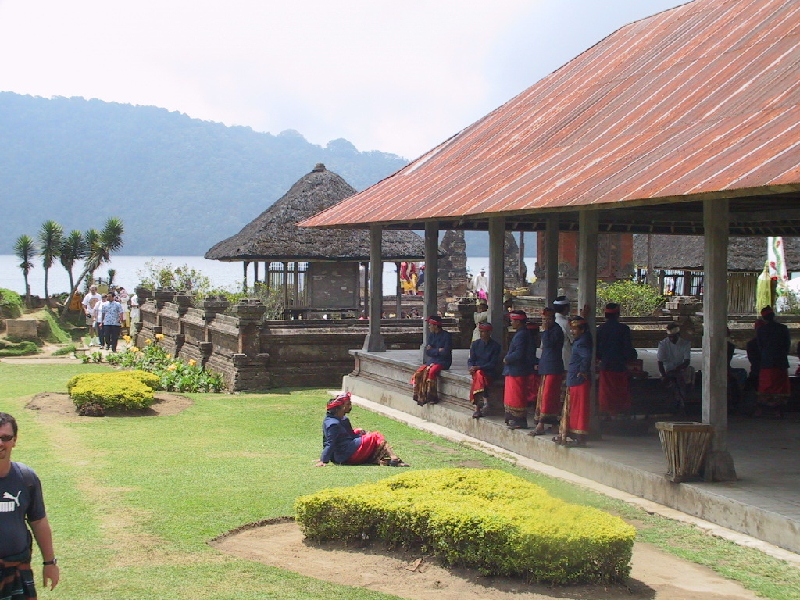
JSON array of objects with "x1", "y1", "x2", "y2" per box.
[{"x1": 0, "y1": 0, "x2": 682, "y2": 158}]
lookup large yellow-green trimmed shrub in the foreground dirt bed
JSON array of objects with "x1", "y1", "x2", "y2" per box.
[{"x1": 295, "y1": 469, "x2": 636, "y2": 583}]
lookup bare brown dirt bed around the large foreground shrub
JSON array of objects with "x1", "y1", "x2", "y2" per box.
[{"x1": 212, "y1": 522, "x2": 757, "y2": 600}]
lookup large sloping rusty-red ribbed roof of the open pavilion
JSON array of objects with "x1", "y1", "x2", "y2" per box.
[{"x1": 302, "y1": 0, "x2": 800, "y2": 226}]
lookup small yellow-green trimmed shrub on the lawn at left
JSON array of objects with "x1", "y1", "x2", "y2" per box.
[{"x1": 67, "y1": 371, "x2": 158, "y2": 410}]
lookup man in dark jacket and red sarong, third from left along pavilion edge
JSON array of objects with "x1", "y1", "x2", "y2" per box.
[{"x1": 503, "y1": 310, "x2": 533, "y2": 429}]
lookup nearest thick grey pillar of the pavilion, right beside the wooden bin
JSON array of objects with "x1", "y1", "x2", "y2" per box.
[{"x1": 703, "y1": 199, "x2": 736, "y2": 481}]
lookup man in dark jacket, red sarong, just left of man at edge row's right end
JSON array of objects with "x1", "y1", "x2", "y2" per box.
[{"x1": 529, "y1": 306, "x2": 564, "y2": 436}]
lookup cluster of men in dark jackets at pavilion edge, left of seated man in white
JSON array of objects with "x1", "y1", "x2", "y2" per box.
[{"x1": 411, "y1": 296, "x2": 636, "y2": 445}]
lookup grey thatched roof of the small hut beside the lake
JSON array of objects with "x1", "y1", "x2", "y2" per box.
[{"x1": 205, "y1": 164, "x2": 425, "y2": 261}]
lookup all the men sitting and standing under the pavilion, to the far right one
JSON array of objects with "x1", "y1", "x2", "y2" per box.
[{"x1": 412, "y1": 296, "x2": 790, "y2": 446}]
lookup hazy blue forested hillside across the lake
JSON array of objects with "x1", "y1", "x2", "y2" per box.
[{"x1": 0, "y1": 92, "x2": 406, "y2": 255}]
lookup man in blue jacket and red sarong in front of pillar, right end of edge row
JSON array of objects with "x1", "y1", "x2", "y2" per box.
[{"x1": 553, "y1": 317, "x2": 592, "y2": 446}]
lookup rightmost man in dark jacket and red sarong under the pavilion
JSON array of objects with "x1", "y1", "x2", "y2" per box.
[{"x1": 755, "y1": 306, "x2": 792, "y2": 417}]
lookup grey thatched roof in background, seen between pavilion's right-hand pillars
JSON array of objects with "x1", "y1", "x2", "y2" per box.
[{"x1": 633, "y1": 235, "x2": 800, "y2": 271}]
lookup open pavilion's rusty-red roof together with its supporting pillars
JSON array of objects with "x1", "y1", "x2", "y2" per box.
[{"x1": 302, "y1": 0, "x2": 800, "y2": 492}]
